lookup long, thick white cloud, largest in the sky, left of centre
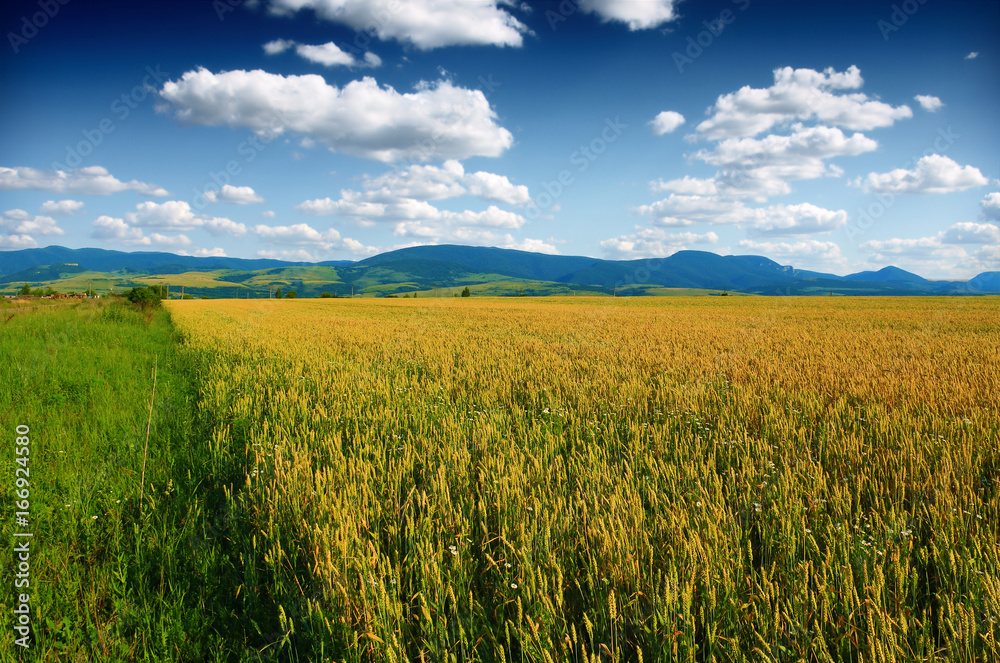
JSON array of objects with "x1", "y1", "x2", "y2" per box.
[{"x1": 160, "y1": 69, "x2": 513, "y2": 162}]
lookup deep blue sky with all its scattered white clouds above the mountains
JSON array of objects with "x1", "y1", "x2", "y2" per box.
[{"x1": 0, "y1": 0, "x2": 1000, "y2": 278}]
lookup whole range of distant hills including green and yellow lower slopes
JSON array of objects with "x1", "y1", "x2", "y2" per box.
[{"x1": 0, "y1": 245, "x2": 1000, "y2": 298}]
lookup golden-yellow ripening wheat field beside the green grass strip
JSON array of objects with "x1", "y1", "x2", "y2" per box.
[{"x1": 168, "y1": 297, "x2": 1000, "y2": 662}]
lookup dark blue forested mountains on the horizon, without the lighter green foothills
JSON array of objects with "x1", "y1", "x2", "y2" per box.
[{"x1": 0, "y1": 244, "x2": 1000, "y2": 295}]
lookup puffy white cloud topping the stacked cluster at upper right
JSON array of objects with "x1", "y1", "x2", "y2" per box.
[{"x1": 696, "y1": 65, "x2": 913, "y2": 140}]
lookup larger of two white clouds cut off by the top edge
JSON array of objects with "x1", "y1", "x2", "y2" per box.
[{"x1": 270, "y1": 0, "x2": 532, "y2": 50}]
